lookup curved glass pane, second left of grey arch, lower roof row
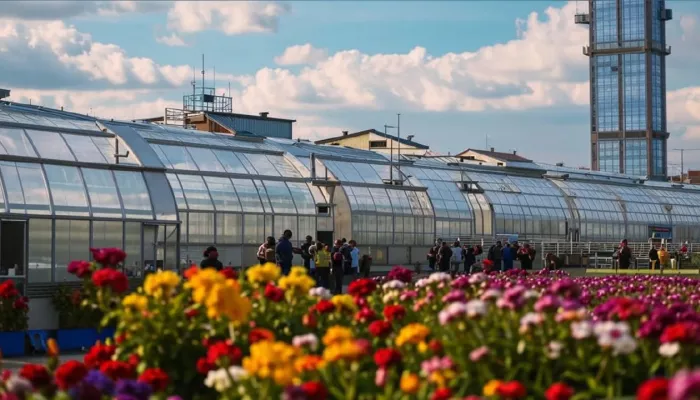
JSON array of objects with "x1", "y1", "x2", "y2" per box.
[{"x1": 83, "y1": 168, "x2": 123, "y2": 218}]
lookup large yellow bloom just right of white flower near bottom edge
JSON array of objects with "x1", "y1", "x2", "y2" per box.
[{"x1": 243, "y1": 341, "x2": 299, "y2": 386}]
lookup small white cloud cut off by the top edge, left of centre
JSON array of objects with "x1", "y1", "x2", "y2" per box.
[{"x1": 168, "y1": 1, "x2": 289, "y2": 35}]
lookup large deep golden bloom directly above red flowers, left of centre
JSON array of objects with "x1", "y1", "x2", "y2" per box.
[{"x1": 205, "y1": 279, "x2": 252, "y2": 322}]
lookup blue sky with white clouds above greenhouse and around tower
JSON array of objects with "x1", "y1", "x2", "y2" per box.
[{"x1": 0, "y1": 1, "x2": 700, "y2": 172}]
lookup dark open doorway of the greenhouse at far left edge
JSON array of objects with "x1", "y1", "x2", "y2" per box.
[{"x1": 0, "y1": 221, "x2": 27, "y2": 278}]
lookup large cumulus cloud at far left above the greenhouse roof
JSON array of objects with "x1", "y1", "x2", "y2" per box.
[{"x1": 0, "y1": 19, "x2": 191, "y2": 88}]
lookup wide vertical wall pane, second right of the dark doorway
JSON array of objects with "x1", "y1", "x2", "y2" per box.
[{"x1": 55, "y1": 219, "x2": 90, "y2": 282}]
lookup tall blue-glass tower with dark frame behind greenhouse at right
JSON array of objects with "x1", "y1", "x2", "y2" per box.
[{"x1": 576, "y1": 0, "x2": 672, "y2": 180}]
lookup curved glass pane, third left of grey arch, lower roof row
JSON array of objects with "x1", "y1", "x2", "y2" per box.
[{"x1": 44, "y1": 165, "x2": 90, "y2": 217}]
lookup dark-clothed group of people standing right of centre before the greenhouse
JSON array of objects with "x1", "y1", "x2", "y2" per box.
[{"x1": 427, "y1": 239, "x2": 536, "y2": 273}]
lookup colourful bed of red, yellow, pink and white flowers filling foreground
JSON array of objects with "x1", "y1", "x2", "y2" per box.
[{"x1": 3, "y1": 250, "x2": 700, "y2": 400}]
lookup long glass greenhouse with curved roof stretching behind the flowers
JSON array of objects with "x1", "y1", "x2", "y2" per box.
[{"x1": 0, "y1": 103, "x2": 700, "y2": 292}]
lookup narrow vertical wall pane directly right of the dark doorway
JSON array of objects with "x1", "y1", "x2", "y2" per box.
[{"x1": 27, "y1": 218, "x2": 53, "y2": 283}]
